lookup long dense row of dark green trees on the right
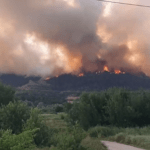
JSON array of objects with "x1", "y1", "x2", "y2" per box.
[{"x1": 65, "y1": 88, "x2": 150, "y2": 130}]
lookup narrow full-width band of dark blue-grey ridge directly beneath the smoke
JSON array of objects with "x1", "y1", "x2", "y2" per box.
[{"x1": 0, "y1": 72, "x2": 150, "y2": 91}]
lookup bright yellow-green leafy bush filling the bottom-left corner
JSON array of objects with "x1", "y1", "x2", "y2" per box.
[{"x1": 0, "y1": 129, "x2": 37, "y2": 150}]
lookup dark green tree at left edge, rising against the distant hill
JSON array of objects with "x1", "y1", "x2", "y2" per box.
[{"x1": 0, "y1": 82, "x2": 15, "y2": 106}]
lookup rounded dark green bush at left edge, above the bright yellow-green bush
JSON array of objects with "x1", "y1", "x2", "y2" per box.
[{"x1": 0, "y1": 101, "x2": 30, "y2": 134}]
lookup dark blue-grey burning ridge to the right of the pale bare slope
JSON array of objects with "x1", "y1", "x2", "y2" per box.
[{"x1": 46, "y1": 72, "x2": 150, "y2": 91}]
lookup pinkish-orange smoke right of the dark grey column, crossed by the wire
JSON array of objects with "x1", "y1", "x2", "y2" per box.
[{"x1": 99, "y1": 0, "x2": 150, "y2": 76}]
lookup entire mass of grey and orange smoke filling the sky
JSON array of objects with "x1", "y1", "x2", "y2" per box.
[{"x1": 0, "y1": 0, "x2": 150, "y2": 77}]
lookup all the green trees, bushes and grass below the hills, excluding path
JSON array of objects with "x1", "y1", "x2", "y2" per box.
[{"x1": 0, "y1": 81, "x2": 150, "y2": 150}]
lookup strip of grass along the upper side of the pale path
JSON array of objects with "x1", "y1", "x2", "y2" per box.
[{"x1": 88, "y1": 126, "x2": 150, "y2": 150}]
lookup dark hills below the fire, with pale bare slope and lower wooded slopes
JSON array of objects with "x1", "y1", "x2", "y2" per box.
[{"x1": 0, "y1": 72, "x2": 150, "y2": 105}]
